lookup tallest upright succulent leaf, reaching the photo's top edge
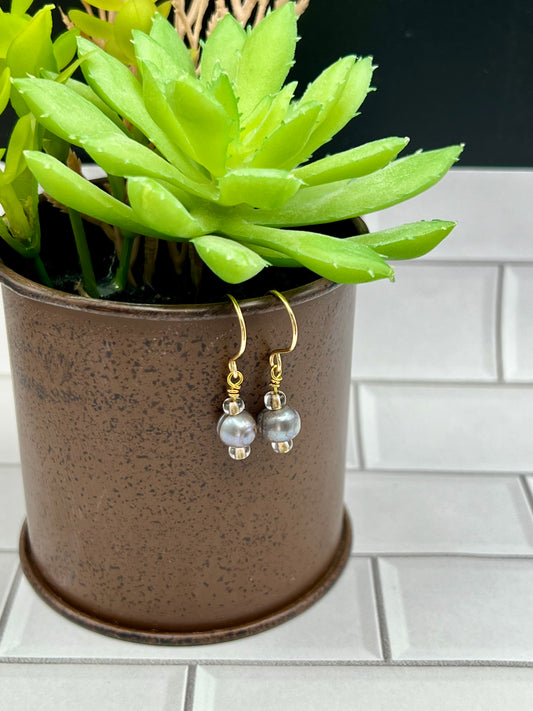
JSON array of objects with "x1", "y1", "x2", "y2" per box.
[{"x1": 236, "y1": 2, "x2": 297, "y2": 117}]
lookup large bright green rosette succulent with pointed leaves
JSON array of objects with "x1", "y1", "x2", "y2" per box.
[{"x1": 5, "y1": 2, "x2": 462, "y2": 296}]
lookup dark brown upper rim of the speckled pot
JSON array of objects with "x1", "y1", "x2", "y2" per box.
[{"x1": 0, "y1": 259, "x2": 343, "y2": 320}]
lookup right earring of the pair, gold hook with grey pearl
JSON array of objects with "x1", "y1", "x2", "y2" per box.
[{"x1": 257, "y1": 291, "x2": 301, "y2": 454}]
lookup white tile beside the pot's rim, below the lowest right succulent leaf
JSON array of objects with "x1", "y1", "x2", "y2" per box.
[{"x1": 352, "y1": 264, "x2": 498, "y2": 380}]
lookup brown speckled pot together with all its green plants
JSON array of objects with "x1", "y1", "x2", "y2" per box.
[{"x1": 0, "y1": 0, "x2": 461, "y2": 644}]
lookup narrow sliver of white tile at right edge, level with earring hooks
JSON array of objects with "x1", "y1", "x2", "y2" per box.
[{"x1": 502, "y1": 266, "x2": 533, "y2": 382}]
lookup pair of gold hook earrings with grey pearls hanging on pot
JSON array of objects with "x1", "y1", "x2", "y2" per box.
[{"x1": 217, "y1": 291, "x2": 301, "y2": 460}]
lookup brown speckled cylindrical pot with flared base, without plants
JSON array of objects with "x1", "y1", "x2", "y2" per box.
[{"x1": 0, "y1": 267, "x2": 354, "y2": 644}]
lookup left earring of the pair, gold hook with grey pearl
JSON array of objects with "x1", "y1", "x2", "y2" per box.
[{"x1": 217, "y1": 294, "x2": 257, "y2": 460}]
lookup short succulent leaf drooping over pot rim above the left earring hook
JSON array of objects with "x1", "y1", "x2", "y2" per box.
[{"x1": 191, "y1": 235, "x2": 269, "y2": 284}]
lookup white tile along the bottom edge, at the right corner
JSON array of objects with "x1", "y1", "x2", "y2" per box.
[{"x1": 193, "y1": 666, "x2": 533, "y2": 711}]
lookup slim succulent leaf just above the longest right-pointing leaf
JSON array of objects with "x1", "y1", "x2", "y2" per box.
[{"x1": 294, "y1": 137, "x2": 409, "y2": 185}]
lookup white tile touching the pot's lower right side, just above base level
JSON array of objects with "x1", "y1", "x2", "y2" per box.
[{"x1": 346, "y1": 472, "x2": 533, "y2": 555}]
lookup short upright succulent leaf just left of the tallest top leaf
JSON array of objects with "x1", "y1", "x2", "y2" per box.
[{"x1": 201, "y1": 14, "x2": 246, "y2": 83}]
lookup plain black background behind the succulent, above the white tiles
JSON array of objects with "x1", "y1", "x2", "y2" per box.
[{"x1": 0, "y1": 0, "x2": 533, "y2": 167}]
